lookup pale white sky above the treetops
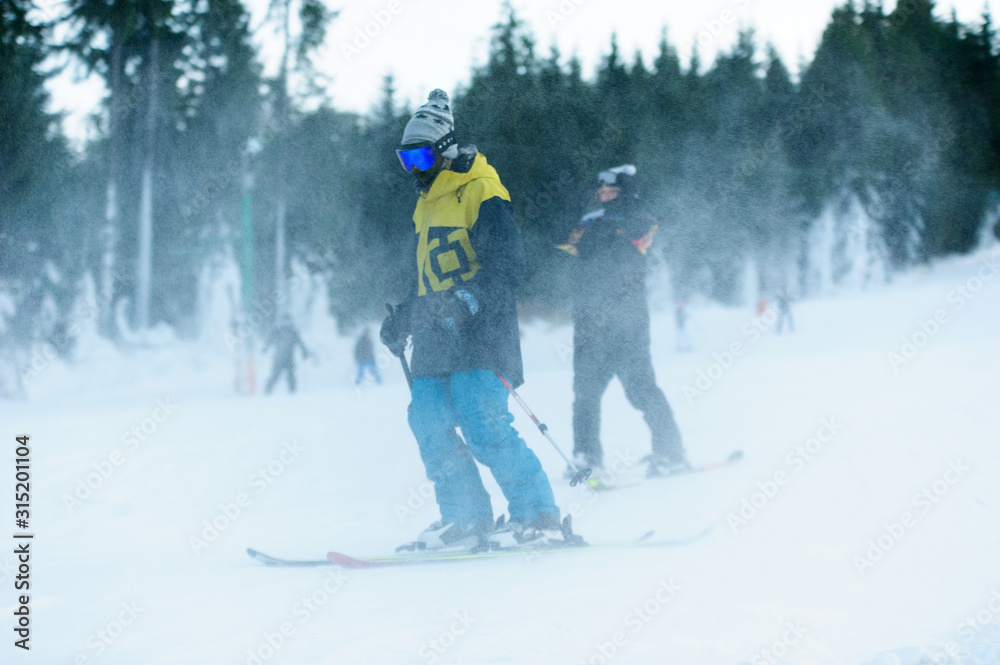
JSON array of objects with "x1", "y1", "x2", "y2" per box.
[{"x1": 42, "y1": 0, "x2": 1000, "y2": 144}]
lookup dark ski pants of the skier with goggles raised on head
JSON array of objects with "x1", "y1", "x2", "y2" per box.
[{"x1": 573, "y1": 337, "x2": 684, "y2": 464}]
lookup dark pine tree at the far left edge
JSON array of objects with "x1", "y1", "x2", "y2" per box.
[{"x1": 0, "y1": 0, "x2": 72, "y2": 360}]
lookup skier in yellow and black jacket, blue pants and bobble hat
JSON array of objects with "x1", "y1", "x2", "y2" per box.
[{"x1": 380, "y1": 89, "x2": 569, "y2": 551}]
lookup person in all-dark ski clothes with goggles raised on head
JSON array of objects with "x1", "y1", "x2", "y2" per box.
[{"x1": 559, "y1": 164, "x2": 690, "y2": 477}]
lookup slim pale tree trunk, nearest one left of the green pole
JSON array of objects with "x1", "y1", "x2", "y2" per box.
[{"x1": 135, "y1": 31, "x2": 160, "y2": 330}]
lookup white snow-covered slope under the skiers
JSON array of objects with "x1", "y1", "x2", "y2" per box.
[{"x1": 0, "y1": 246, "x2": 1000, "y2": 665}]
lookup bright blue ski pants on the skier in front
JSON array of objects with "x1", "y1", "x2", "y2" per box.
[{"x1": 409, "y1": 370, "x2": 559, "y2": 531}]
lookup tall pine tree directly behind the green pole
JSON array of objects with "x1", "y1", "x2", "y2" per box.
[{"x1": 172, "y1": 0, "x2": 263, "y2": 330}]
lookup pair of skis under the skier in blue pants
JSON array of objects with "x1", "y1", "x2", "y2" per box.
[{"x1": 247, "y1": 525, "x2": 715, "y2": 568}]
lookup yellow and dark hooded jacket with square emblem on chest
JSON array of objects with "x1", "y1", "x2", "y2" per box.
[{"x1": 401, "y1": 148, "x2": 525, "y2": 386}]
